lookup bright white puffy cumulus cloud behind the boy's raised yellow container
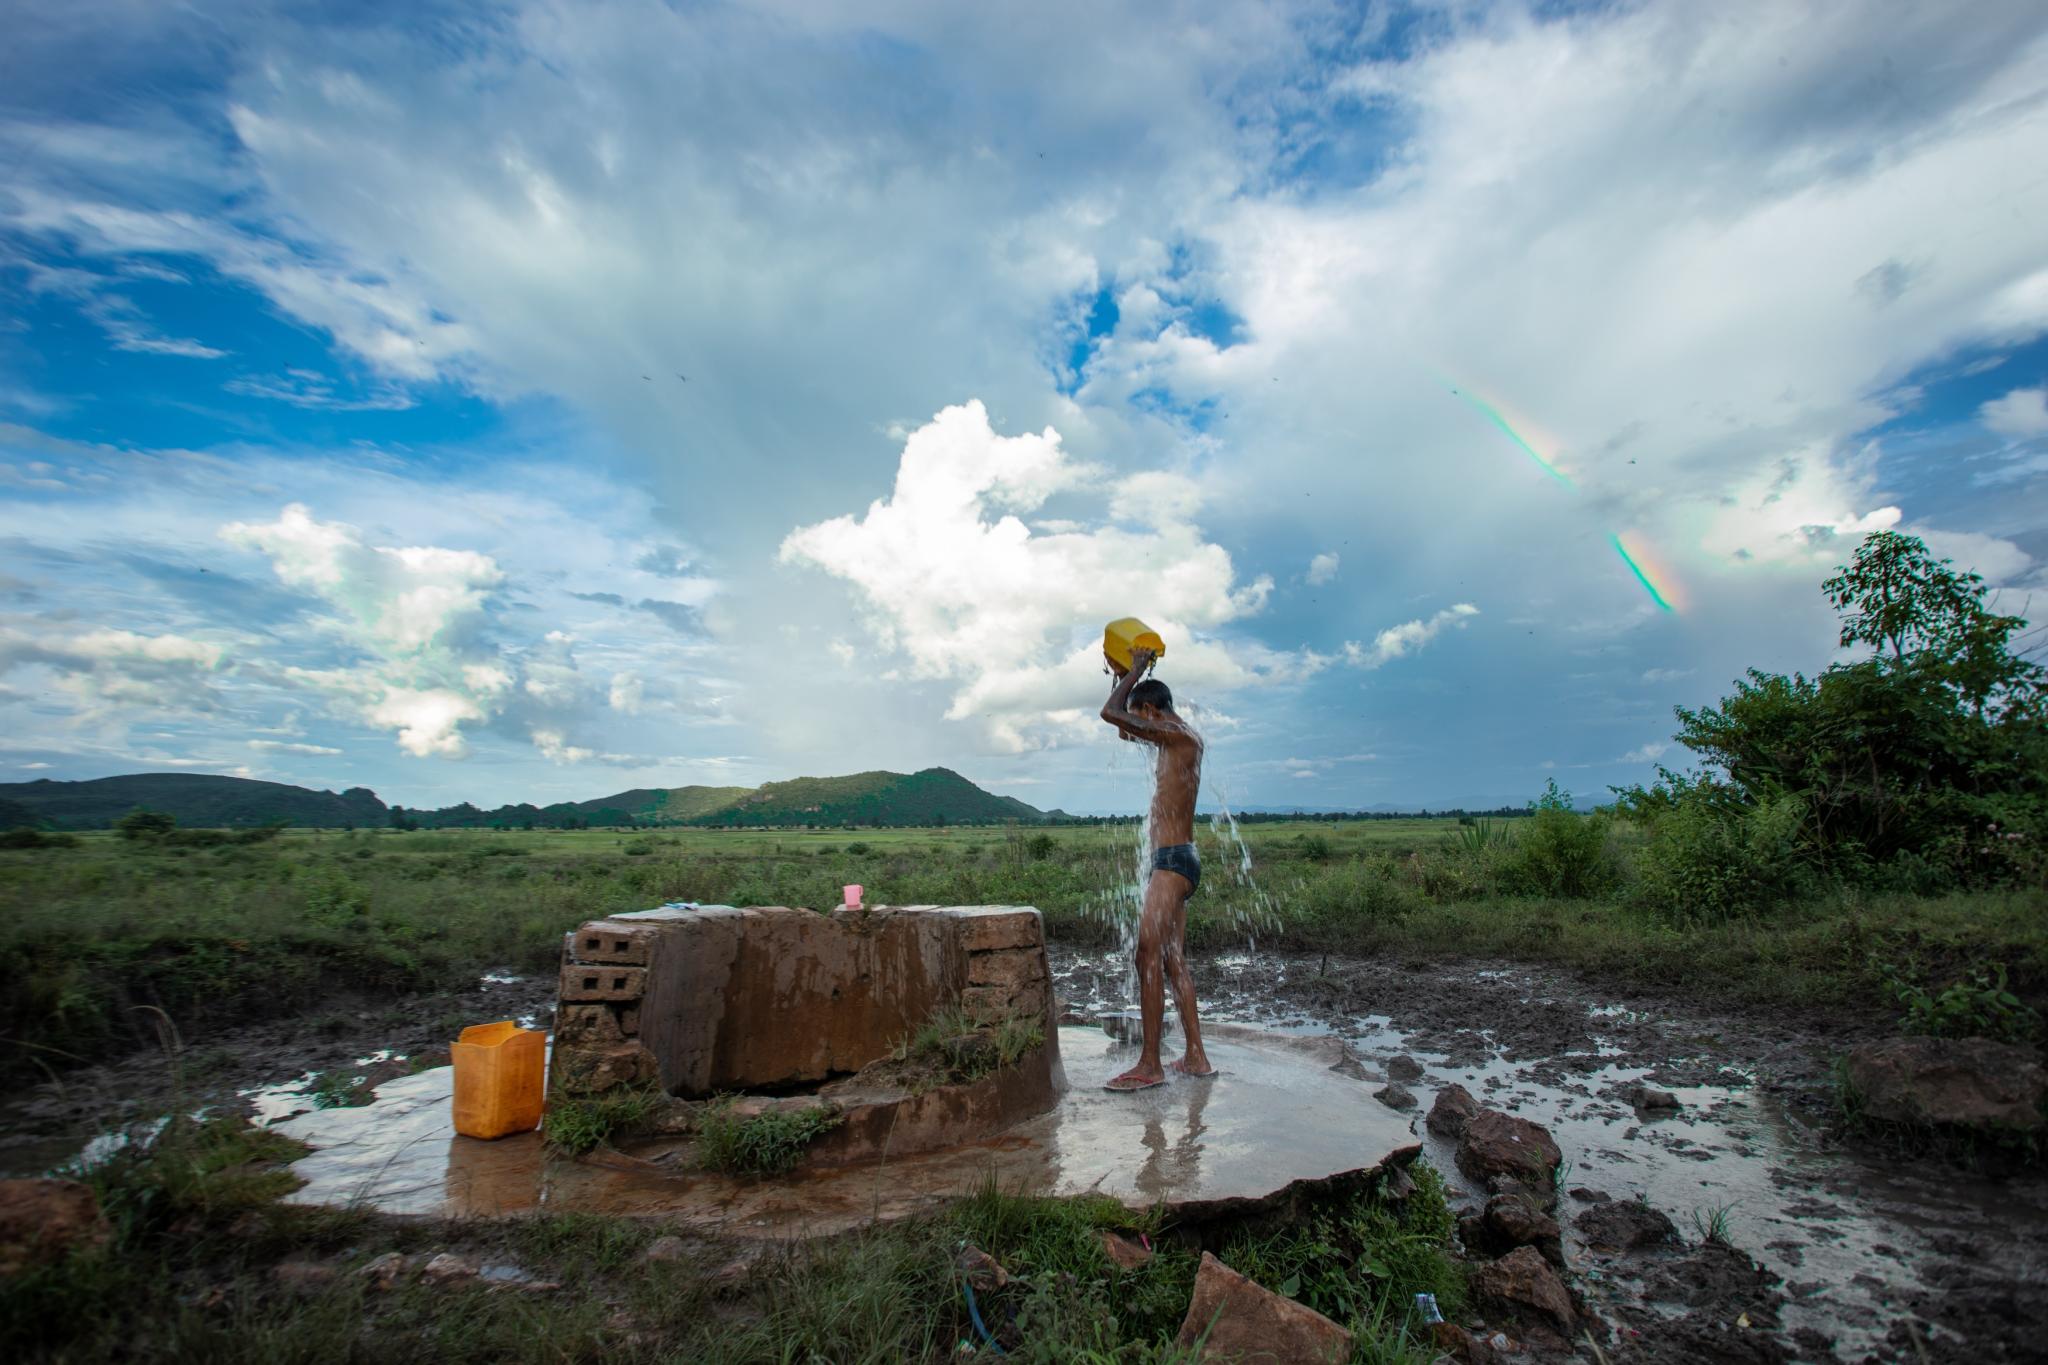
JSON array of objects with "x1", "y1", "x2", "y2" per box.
[{"x1": 782, "y1": 401, "x2": 1292, "y2": 751}]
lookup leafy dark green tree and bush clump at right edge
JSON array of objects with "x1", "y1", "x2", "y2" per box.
[{"x1": 1618, "y1": 532, "x2": 2048, "y2": 894}]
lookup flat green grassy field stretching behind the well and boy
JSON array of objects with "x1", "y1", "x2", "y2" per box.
[{"x1": 0, "y1": 817, "x2": 2048, "y2": 1074}]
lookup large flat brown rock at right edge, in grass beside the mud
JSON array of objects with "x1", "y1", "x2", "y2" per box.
[{"x1": 1843, "y1": 1038, "x2": 2048, "y2": 1132}]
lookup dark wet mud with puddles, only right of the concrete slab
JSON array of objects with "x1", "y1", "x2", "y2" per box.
[{"x1": 1055, "y1": 952, "x2": 2048, "y2": 1361}]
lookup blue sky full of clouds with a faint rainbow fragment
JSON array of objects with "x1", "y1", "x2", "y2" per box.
[{"x1": 0, "y1": 0, "x2": 2048, "y2": 810}]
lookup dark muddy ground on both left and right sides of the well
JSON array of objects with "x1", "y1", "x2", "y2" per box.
[{"x1": 0, "y1": 950, "x2": 2048, "y2": 1363}]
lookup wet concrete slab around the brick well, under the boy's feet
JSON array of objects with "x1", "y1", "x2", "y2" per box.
[{"x1": 276, "y1": 1027, "x2": 1415, "y2": 1238}]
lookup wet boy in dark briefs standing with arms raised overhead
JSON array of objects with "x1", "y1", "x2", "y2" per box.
[{"x1": 1102, "y1": 649, "x2": 1217, "y2": 1091}]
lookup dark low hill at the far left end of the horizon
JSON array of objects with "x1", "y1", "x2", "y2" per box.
[{"x1": 0, "y1": 774, "x2": 387, "y2": 829}]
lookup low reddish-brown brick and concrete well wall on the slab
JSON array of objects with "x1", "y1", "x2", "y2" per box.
[{"x1": 553, "y1": 905, "x2": 1061, "y2": 1160}]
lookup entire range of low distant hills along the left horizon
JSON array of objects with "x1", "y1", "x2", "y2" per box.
[{"x1": 0, "y1": 767, "x2": 1065, "y2": 829}]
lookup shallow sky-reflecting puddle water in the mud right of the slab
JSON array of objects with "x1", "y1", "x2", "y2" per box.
[{"x1": 1202, "y1": 972, "x2": 2048, "y2": 1359}]
